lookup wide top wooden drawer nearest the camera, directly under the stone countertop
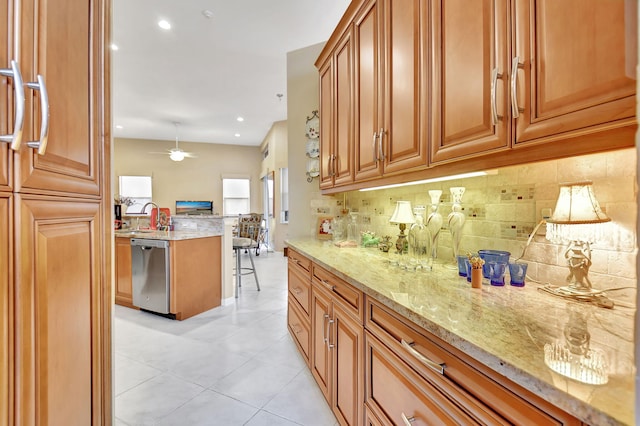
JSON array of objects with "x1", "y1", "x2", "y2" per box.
[{"x1": 365, "y1": 299, "x2": 581, "y2": 426}]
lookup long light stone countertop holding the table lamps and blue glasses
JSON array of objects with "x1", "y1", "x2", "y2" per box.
[{"x1": 286, "y1": 239, "x2": 635, "y2": 425}]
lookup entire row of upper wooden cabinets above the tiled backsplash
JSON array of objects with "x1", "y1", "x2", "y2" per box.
[{"x1": 316, "y1": 0, "x2": 637, "y2": 192}]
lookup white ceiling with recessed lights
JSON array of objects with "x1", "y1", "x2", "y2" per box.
[{"x1": 111, "y1": 0, "x2": 349, "y2": 146}]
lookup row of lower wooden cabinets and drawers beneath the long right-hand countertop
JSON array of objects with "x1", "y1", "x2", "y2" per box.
[{"x1": 288, "y1": 253, "x2": 581, "y2": 426}]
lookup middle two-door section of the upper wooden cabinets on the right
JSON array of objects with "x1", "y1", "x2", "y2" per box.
[{"x1": 354, "y1": 0, "x2": 430, "y2": 181}]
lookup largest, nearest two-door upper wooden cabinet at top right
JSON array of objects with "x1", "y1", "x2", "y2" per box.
[{"x1": 431, "y1": 0, "x2": 637, "y2": 164}]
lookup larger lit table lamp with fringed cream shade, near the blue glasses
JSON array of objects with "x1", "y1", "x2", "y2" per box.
[{"x1": 545, "y1": 181, "x2": 611, "y2": 301}]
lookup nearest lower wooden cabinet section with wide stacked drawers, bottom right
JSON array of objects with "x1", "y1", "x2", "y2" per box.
[{"x1": 365, "y1": 298, "x2": 581, "y2": 426}]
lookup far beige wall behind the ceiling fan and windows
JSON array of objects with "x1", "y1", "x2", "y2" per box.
[{"x1": 113, "y1": 139, "x2": 262, "y2": 214}]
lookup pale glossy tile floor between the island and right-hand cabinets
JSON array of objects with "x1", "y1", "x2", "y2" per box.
[{"x1": 114, "y1": 251, "x2": 337, "y2": 426}]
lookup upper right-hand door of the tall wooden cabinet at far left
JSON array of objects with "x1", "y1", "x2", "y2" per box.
[{"x1": 15, "y1": 0, "x2": 101, "y2": 195}]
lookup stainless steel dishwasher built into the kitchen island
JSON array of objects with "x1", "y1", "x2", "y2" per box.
[{"x1": 131, "y1": 238, "x2": 170, "y2": 314}]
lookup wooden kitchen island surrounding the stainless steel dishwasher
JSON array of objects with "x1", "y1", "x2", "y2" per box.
[{"x1": 115, "y1": 230, "x2": 222, "y2": 320}]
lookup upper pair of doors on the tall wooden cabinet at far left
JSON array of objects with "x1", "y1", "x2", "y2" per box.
[{"x1": 0, "y1": 0, "x2": 105, "y2": 197}]
